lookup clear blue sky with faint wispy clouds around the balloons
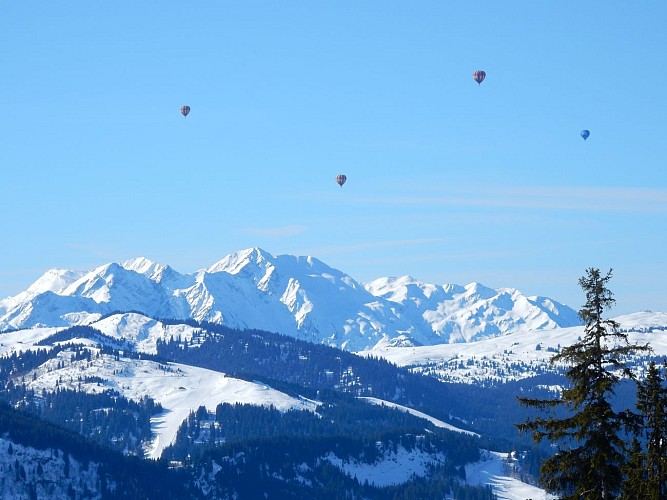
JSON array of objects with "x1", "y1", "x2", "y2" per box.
[{"x1": 0, "y1": 0, "x2": 667, "y2": 314}]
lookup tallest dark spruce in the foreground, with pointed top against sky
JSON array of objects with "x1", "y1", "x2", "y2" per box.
[{"x1": 517, "y1": 268, "x2": 648, "y2": 500}]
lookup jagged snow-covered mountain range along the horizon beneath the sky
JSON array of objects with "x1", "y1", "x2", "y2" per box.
[{"x1": 0, "y1": 248, "x2": 579, "y2": 351}]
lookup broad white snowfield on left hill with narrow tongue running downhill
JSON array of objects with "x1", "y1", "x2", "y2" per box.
[{"x1": 16, "y1": 351, "x2": 317, "y2": 458}]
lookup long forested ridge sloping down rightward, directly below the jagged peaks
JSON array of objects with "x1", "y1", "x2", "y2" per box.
[{"x1": 157, "y1": 323, "x2": 562, "y2": 449}]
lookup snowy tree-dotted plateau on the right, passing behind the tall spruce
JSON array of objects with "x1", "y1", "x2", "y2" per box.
[{"x1": 358, "y1": 312, "x2": 667, "y2": 383}]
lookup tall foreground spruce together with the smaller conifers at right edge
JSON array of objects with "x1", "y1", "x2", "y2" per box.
[{"x1": 517, "y1": 268, "x2": 667, "y2": 500}]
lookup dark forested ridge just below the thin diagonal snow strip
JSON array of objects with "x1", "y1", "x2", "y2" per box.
[{"x1": 164, "y1": 393, "x2": 480, "y2": 465}]
